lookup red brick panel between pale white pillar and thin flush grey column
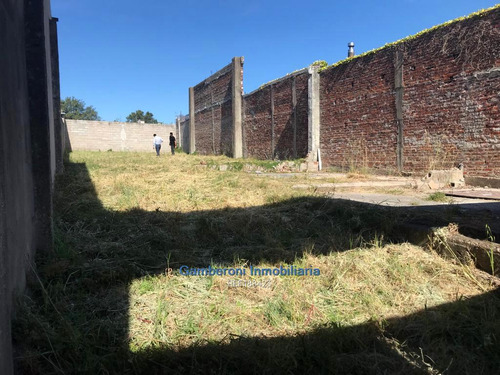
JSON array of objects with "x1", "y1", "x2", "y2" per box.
[{"x1": 320, "y1": 49, "x2": 396, "y2": 170}]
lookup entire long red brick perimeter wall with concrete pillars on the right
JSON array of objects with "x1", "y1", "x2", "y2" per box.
[{"x1": 180, "y1": 6, "x2": 500, "y2": 177}]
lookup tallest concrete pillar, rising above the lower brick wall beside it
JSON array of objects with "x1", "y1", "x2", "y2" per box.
[{"x1": 232, "y1": 57, "x2": 243, "y2": 158}]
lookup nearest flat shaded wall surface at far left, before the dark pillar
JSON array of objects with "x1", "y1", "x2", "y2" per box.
[{"x1": 0, "y1": 0, "x2": 34, "y2": 374}]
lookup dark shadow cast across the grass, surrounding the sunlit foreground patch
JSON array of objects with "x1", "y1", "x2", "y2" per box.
[{"x1": 14, "y1": 163, "x2": 500, "y2": 374}]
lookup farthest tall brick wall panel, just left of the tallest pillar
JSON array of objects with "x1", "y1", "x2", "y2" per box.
[{"x1": 194, "y1": 64, "x2": 233, "y2": 155}]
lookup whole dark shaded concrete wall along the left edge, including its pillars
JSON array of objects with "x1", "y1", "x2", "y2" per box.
[{"x1": 0, "y1": 0, "x2": 58, "y2": 374}]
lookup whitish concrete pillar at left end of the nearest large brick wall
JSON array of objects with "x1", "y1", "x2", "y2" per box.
[{"x1": 307, "y1": 65, "x2": 320, "y2": 161}]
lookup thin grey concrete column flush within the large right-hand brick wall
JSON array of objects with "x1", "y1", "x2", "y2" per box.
[{"x1": 394, "y1": 50, "x2": 404, "y2": 172}]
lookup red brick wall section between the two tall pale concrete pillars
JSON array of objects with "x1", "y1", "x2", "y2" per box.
[{"x1": 243, "y1": 71, "x2": 309, "y2": 159}]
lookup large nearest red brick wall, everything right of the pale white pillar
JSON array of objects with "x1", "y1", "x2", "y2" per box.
[{"x1": 320, "y1": 8, "x2": 500, "y2": 176}]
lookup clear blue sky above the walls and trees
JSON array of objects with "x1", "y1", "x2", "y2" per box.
[{"x1": 52, "y1": 0, "x2": 496, "y2": 123}]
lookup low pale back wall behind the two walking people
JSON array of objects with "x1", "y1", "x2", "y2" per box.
[{"x1": 66, "y1": 119, "x2": 176, "y2": 152}]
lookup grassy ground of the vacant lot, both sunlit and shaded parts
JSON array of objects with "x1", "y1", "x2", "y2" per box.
[{"x1": 15, "y1": 152, "x2": 500, "y2": 374}]
